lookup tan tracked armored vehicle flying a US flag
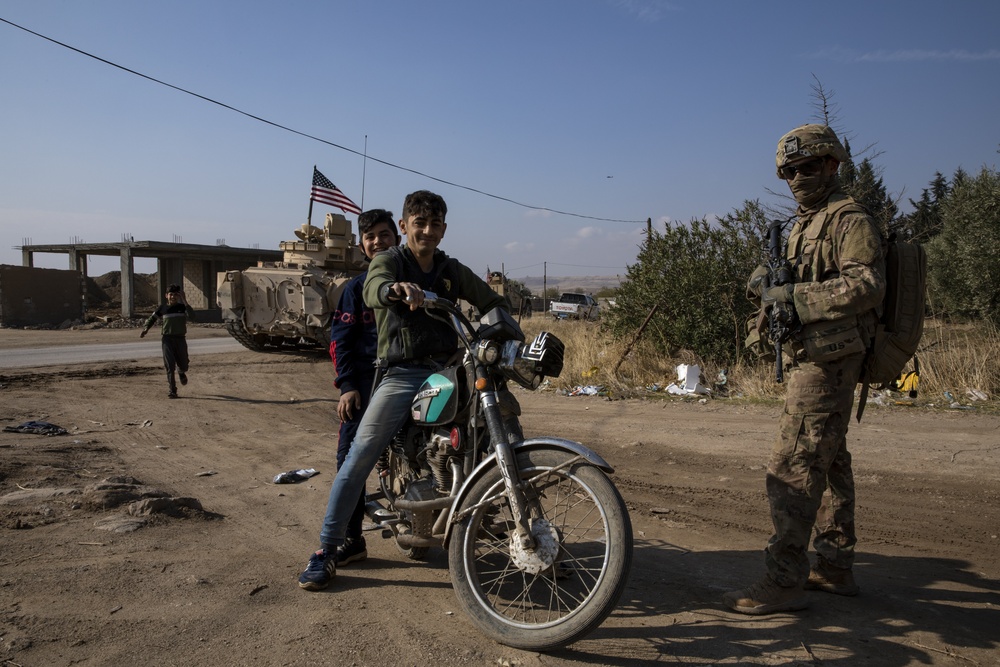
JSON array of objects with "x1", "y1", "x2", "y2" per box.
[{"x1": 218, "y1": 213, "x2": 367, "y2": 352}]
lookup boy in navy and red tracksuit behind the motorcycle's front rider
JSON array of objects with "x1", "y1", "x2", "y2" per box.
[{"x1": 327, "y1": 208, "x2": 399, "y2": 565}]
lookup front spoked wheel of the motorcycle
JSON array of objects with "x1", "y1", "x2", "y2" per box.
[{"x1": 448, "y1": 450, "x2": 632, "y2": 651}]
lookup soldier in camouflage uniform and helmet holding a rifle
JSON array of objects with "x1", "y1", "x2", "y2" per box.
[{"x1": 723, "y1": 125, "x2": 885, "y2": 614}]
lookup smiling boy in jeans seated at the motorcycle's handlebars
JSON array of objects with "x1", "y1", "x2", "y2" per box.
[{"x1": 299, "y1": 190, "x2": 507, "y2": 591}]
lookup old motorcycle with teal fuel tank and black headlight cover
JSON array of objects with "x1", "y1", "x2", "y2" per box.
[{"x1": 366, "y1": 292, "x2": 632, "y2": 651}]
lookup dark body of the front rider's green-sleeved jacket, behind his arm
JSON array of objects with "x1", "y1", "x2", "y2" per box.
[{"x1": 380, "y1": 246, "x2": 459, "y2": 365}]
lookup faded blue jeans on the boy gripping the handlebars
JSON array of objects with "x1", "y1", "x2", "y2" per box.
[{"x1": 319, "y1": 366, "x2": 433, "y2": 550}]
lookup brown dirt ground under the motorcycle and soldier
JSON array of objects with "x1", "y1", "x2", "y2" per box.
[{"x1": 0, "y1": 329, "x2": 1000, "y2": 667}]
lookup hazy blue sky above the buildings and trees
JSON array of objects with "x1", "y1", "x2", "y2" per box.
[{"x1": 0, "y1": 0, "x2": 1000, "y2": 278}]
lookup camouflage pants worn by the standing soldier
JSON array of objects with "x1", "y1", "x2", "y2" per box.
[{"x1": 764, "y1": 355, "x2": 863, "y2": 586}]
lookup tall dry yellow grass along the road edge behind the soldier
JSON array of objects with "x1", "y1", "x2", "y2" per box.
[{"x1": 521, "y1": 316, "x2": 1000, "y2": 403}]
